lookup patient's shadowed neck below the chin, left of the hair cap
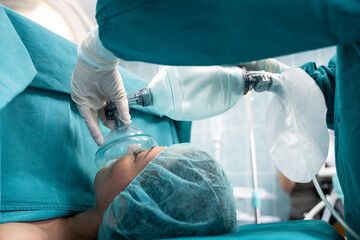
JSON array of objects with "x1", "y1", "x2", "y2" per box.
[{"x1": 64, "y1": 206, "x2": 104, "y2": 240}]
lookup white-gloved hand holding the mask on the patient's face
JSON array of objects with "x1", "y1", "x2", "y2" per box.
[{"x1": 71, "y1": 28, "x2": 131, "y2": 146}]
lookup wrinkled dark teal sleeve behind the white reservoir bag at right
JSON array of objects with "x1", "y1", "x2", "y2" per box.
[{"x1": 300, "y1": 55, "x2": 336, "y2": 130}]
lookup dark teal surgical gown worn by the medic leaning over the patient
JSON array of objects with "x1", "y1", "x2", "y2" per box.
[{"x1": 96, "y1": 0, "x2": 360, "y2": 239}]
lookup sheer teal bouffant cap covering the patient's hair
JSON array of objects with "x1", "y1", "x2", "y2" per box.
[{"x1": 98, "y1": 144, "x2": 237, "y2": 239}]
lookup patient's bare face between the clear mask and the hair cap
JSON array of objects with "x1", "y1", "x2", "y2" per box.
[{"x1": 94, "y1": 147, "x2": 165, "y2": 210}]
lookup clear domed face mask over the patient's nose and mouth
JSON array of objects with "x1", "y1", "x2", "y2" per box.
[{"x1": 95, "y1": 102, "x2": 157, "y2": 168}]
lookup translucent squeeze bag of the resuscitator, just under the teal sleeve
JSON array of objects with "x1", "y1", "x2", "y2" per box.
[{"x1": 128, "y1": 66, "x2": 246, "y2": 121}]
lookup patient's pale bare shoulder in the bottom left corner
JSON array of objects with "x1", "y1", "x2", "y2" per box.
[{"x1": 0, "y1": 223, "x2": 47, "y2": 240}]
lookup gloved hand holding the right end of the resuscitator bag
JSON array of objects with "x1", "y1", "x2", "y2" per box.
[{"x1": 238, "y1": 58, "x2": 289, "y2": 73}]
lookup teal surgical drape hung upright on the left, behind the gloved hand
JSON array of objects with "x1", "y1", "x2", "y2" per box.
[{"x1": 0, "y1": 5, "x2": 190, "y2": 223}]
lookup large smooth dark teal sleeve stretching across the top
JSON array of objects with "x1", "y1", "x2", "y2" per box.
[{"x1": 96, "y1": 0, "x2": 360, "y2": 65}]
